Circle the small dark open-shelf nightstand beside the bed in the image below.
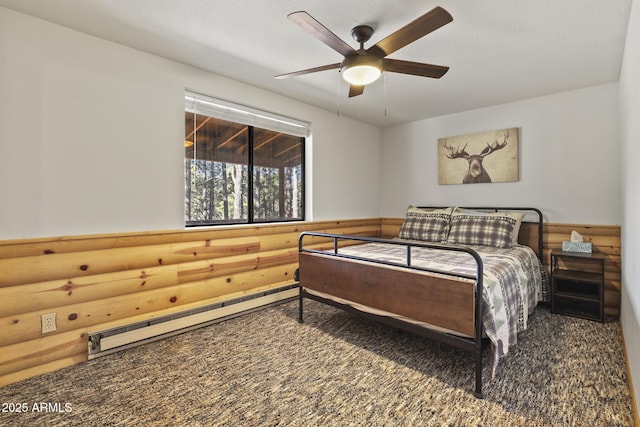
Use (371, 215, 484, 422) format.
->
(551, 251, 605, 322)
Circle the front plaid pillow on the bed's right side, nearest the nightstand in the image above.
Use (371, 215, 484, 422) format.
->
(447, 214, 517, 248)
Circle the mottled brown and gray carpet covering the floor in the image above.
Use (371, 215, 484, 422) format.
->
(0, 301, 633, 426)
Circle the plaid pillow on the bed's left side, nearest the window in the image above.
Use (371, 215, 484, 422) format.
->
(398, 206, 451, 242)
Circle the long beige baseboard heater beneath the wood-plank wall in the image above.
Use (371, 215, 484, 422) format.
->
(88, 284, 299, 359)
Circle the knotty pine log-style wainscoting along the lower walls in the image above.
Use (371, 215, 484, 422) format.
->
(0, 218, 620, 386)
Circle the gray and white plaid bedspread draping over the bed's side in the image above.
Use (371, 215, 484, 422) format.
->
(339, 243, 546, 369)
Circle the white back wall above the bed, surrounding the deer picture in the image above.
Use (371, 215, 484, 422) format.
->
(381, 83, 621, 224)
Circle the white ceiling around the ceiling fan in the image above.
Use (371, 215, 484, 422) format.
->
(0, 0, 632, 126)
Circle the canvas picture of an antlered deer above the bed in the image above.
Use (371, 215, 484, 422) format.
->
(438, 128, 518, 184)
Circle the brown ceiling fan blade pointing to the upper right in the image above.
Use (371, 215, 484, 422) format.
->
(367, 6, 453, 58)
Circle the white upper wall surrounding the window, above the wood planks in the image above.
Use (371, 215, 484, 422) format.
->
(0, 8, 381, 239)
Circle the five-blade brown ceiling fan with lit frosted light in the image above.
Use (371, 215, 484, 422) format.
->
(275, 6, 453, 97)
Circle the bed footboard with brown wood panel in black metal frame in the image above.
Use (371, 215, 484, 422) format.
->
(299, 232, 483, 398)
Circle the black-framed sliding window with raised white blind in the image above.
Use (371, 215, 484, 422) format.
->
(184, 91, 309, 226)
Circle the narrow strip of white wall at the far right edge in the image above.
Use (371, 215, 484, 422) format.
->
(620, 1, 640, 409)
